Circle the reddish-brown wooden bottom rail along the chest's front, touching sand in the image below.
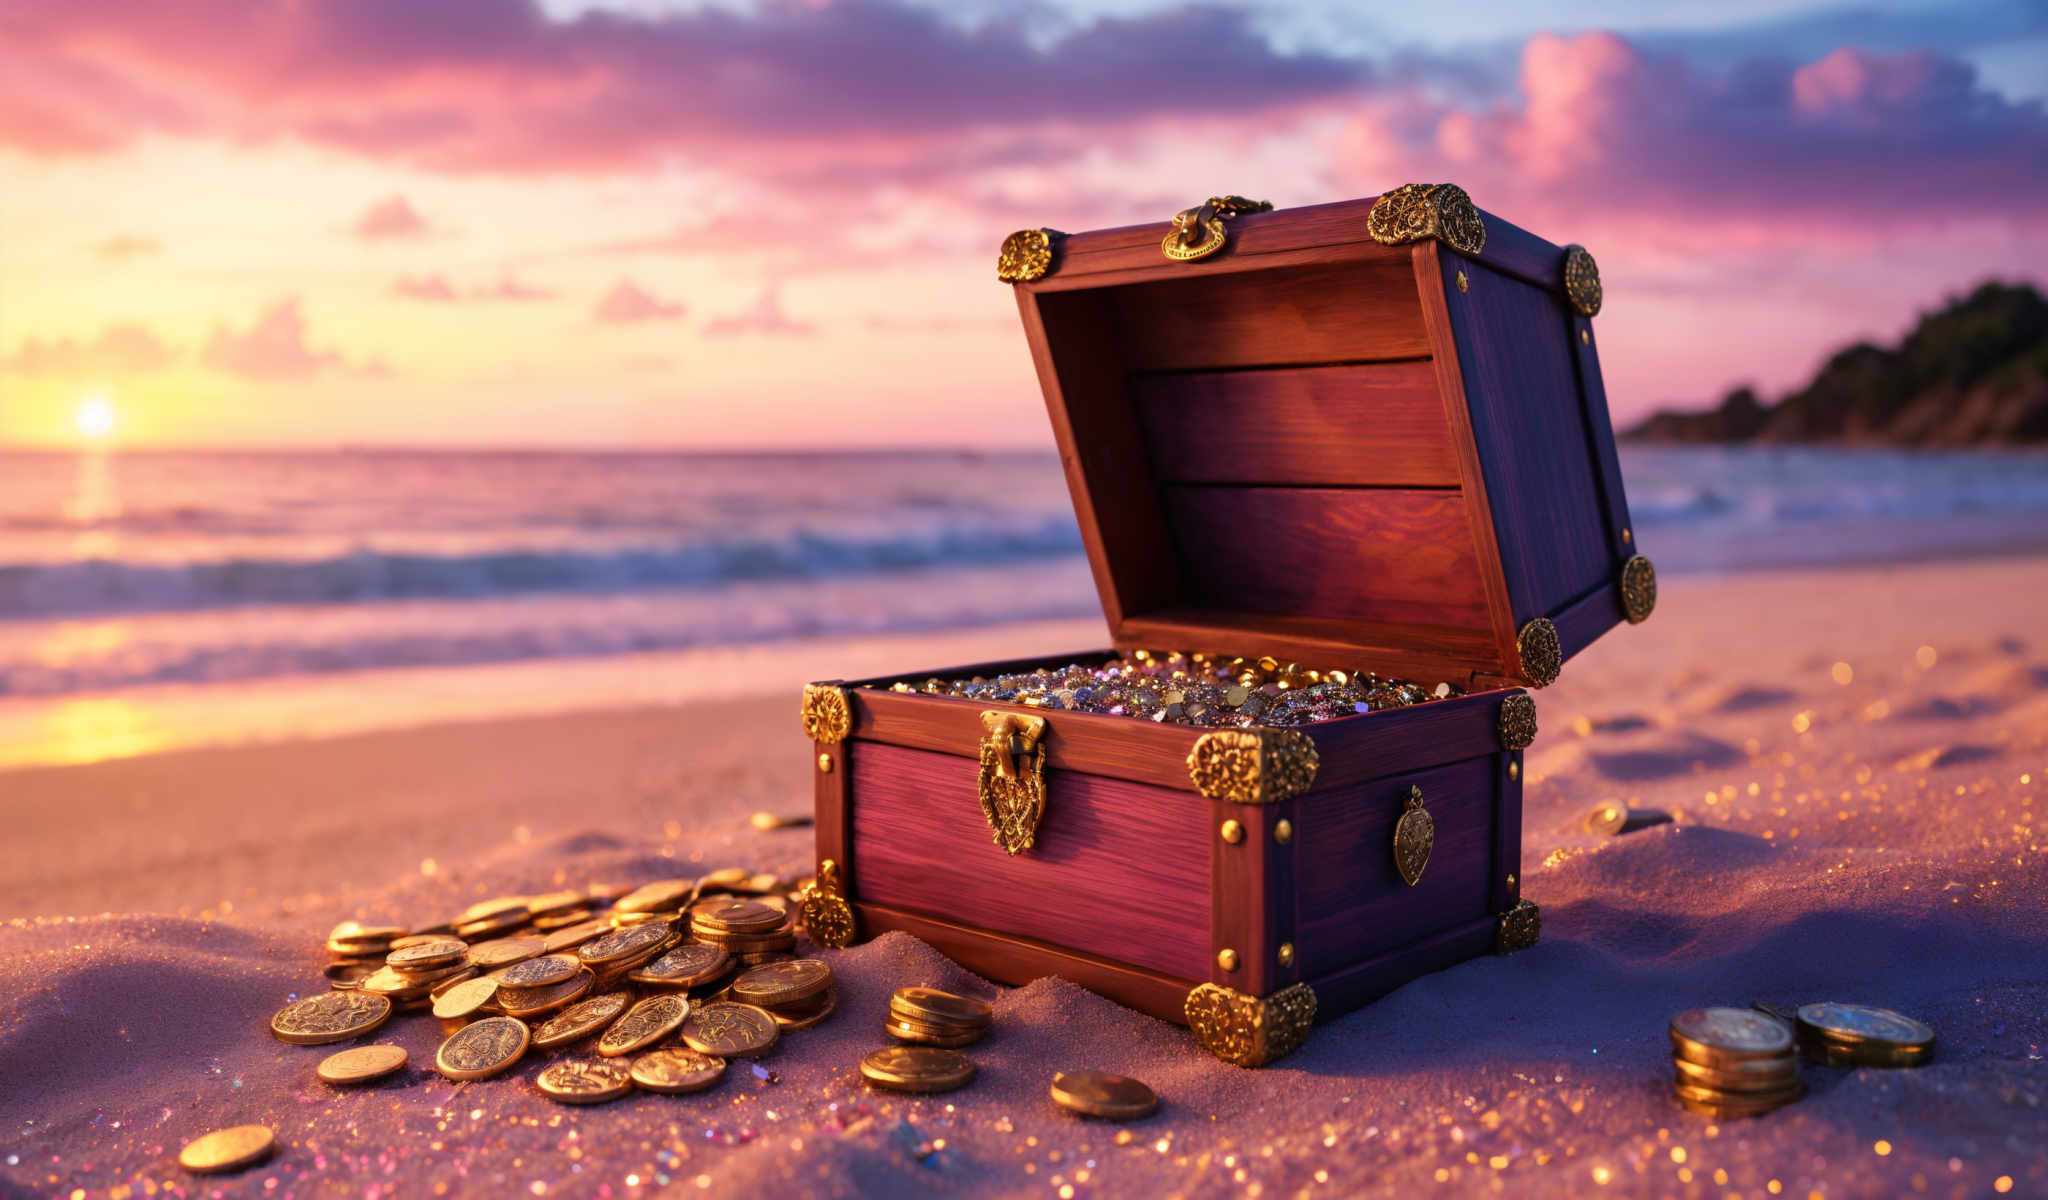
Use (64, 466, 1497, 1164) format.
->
(854, 903, 1194, 1026)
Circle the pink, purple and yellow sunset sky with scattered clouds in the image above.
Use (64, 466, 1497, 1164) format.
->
(0, 0, 2048, 446)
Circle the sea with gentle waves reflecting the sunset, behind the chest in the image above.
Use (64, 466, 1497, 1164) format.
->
(0, 448, 2048, 762)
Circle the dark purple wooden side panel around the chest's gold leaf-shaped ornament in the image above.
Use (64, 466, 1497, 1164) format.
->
(1294, 756, 1499, 979)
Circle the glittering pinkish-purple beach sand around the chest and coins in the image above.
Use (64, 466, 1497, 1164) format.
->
(0, 557, 2048, 1198)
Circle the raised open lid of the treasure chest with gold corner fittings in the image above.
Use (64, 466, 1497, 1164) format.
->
(997, 184, 1657, 688)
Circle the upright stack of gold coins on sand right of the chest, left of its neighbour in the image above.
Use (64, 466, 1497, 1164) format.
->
(1671, 1008, 1806, 1120)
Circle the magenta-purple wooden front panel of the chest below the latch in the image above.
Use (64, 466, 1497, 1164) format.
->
(850, 737, 1210, 979)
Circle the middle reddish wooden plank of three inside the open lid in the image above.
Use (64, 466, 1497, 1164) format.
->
(1130, 362, 1458, 487)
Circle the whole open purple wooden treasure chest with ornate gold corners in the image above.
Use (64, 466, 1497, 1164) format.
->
(803, 184, 1657, 1065)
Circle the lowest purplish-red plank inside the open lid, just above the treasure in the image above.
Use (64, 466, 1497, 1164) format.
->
(1163, 485, 1489, 631)
